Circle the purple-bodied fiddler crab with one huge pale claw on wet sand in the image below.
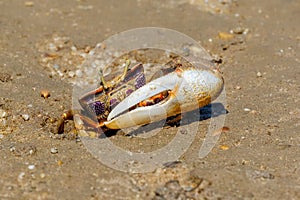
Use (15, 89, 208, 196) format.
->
(58, 57, 224, 133)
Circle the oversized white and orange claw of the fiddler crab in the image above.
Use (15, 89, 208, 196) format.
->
(105, 67, 224, 129)
